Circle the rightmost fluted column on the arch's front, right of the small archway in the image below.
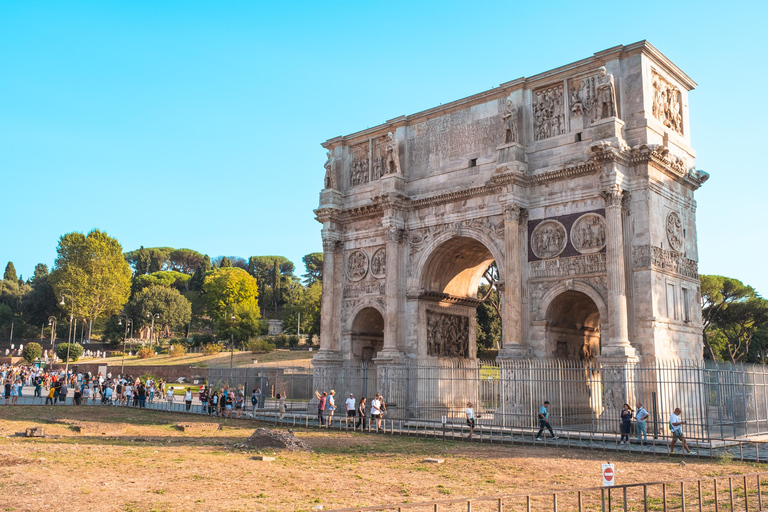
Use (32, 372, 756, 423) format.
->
(601, 185, 635, 357)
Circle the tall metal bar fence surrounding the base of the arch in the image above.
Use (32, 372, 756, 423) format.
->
(209, 359, 768, 439)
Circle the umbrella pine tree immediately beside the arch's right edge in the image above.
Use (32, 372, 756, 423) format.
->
(700, 274, 757, 361)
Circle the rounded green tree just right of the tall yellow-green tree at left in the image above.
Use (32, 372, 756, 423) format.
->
(126, 285, 192, 330)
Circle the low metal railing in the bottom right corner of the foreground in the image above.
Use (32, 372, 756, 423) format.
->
(330, 473, 768, 512)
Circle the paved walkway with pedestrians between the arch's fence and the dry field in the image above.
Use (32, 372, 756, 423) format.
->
(10, 396, 768, 462)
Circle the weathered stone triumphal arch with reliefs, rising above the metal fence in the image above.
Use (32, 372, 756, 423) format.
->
(315, 41, 708, 364)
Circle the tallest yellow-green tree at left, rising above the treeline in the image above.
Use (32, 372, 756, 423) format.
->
(51, 229, 131, 339)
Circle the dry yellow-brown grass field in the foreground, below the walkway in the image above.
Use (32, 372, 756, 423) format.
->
(0, 406, 766, 512)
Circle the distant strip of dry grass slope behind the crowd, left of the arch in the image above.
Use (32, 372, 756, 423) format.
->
(78, 350, 315, 368)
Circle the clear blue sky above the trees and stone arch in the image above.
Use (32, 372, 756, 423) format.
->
(0, 0, 768, 294)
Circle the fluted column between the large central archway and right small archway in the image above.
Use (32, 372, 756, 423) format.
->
(499, 204, 529, 358)
